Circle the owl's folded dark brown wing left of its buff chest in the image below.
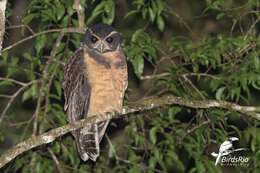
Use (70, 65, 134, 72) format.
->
(63, 48, 91, 123)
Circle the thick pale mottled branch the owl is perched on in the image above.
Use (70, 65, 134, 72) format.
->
(0, 96, 260, 168)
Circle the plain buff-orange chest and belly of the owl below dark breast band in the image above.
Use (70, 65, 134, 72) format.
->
(84, 53, 127, 115)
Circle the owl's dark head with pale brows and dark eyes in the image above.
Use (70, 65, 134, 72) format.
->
(84, 24, 122, 54)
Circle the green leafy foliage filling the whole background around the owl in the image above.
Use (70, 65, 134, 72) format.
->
(0, 0, 260, 173)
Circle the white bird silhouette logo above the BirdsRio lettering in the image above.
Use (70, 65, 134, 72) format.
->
(211, 137, 246, 166)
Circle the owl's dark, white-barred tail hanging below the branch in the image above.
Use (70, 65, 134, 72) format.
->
(74, 120, 109, 162)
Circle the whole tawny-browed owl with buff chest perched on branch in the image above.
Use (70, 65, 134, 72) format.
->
(63, 24, 127, 161)
